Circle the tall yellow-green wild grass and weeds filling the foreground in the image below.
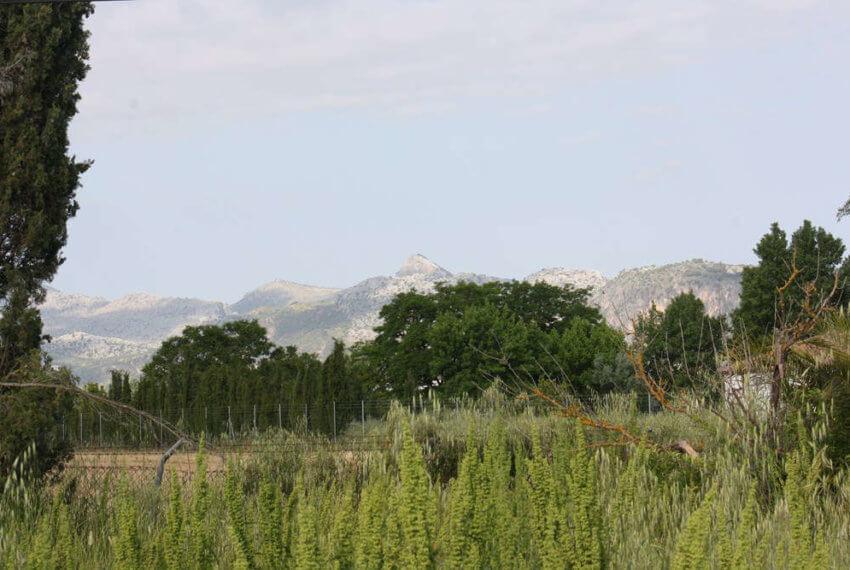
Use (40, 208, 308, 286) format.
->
(0, 393, 850, 569)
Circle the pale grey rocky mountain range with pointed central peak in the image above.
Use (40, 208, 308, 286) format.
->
(40, 254, 743, 382)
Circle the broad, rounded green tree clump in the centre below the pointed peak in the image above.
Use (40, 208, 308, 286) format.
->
(355, 282, 624, 398)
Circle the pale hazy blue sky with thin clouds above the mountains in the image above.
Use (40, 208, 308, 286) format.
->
(54, 0, 850, 301)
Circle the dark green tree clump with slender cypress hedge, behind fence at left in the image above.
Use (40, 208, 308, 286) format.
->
(130, 321, 362, 433)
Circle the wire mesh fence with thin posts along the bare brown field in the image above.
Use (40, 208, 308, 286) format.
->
(57, 390, 653, 492)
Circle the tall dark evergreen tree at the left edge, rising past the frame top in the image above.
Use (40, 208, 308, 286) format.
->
(0, 2, 92, 474)
